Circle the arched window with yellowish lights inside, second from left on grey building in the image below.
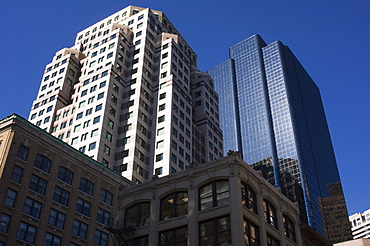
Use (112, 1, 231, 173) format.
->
(161, 192, 189, 220)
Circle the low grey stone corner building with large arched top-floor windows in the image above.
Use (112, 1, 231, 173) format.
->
(112, 152, 304, 246)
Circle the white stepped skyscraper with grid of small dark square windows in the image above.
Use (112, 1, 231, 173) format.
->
(29, 6, 222, 183)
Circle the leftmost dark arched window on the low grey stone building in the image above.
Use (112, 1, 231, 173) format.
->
(124, 202, 150, 228)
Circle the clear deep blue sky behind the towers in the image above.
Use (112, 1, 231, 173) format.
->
(0, 0, 370, 214)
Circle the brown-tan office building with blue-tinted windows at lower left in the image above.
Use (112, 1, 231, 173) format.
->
(0, 114, 133, 246)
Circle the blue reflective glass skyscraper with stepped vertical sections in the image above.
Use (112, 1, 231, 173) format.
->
(208, 35, 351, 242)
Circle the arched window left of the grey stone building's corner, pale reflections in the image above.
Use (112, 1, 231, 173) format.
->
(199, 180, 229, 210)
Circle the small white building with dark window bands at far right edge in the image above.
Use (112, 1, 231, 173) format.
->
(349, 209, 370, 239)
